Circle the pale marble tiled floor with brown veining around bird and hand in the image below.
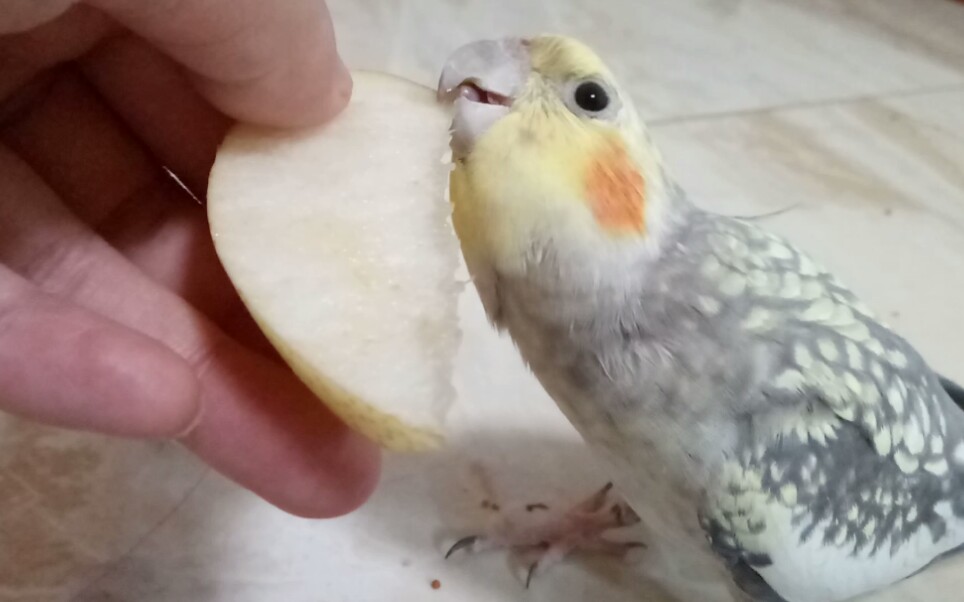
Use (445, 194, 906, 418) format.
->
(0, 0, 964, 602)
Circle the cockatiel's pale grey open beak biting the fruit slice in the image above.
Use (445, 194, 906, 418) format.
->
(438, 38, 531, 158)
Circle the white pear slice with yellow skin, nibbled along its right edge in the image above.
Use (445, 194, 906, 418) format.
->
(208, 72, 462, 451)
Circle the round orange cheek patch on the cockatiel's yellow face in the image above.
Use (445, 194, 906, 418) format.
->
(586, 144, 646, 233)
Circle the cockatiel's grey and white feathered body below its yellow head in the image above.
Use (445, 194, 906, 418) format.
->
(490, 201, 964, 602)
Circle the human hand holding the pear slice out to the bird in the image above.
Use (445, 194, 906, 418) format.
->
(0, 0, 379, 517)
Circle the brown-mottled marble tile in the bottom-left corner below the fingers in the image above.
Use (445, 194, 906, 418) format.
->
(0, 417, 206, 601)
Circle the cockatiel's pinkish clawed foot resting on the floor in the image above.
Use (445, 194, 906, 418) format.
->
(445, 483, 646, 587)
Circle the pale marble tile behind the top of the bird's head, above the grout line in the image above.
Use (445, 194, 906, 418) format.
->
(330, 0, 964, 117)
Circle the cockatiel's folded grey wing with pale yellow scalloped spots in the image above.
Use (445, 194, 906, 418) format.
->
(701, 218, 964, 602)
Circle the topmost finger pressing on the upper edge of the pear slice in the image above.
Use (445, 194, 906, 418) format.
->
(88, 0, 352, 127)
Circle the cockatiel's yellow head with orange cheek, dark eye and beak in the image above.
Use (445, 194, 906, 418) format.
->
(438, 36, 667, 286)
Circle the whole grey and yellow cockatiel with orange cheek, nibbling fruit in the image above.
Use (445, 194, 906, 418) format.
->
(439, 36, 964, 602)
